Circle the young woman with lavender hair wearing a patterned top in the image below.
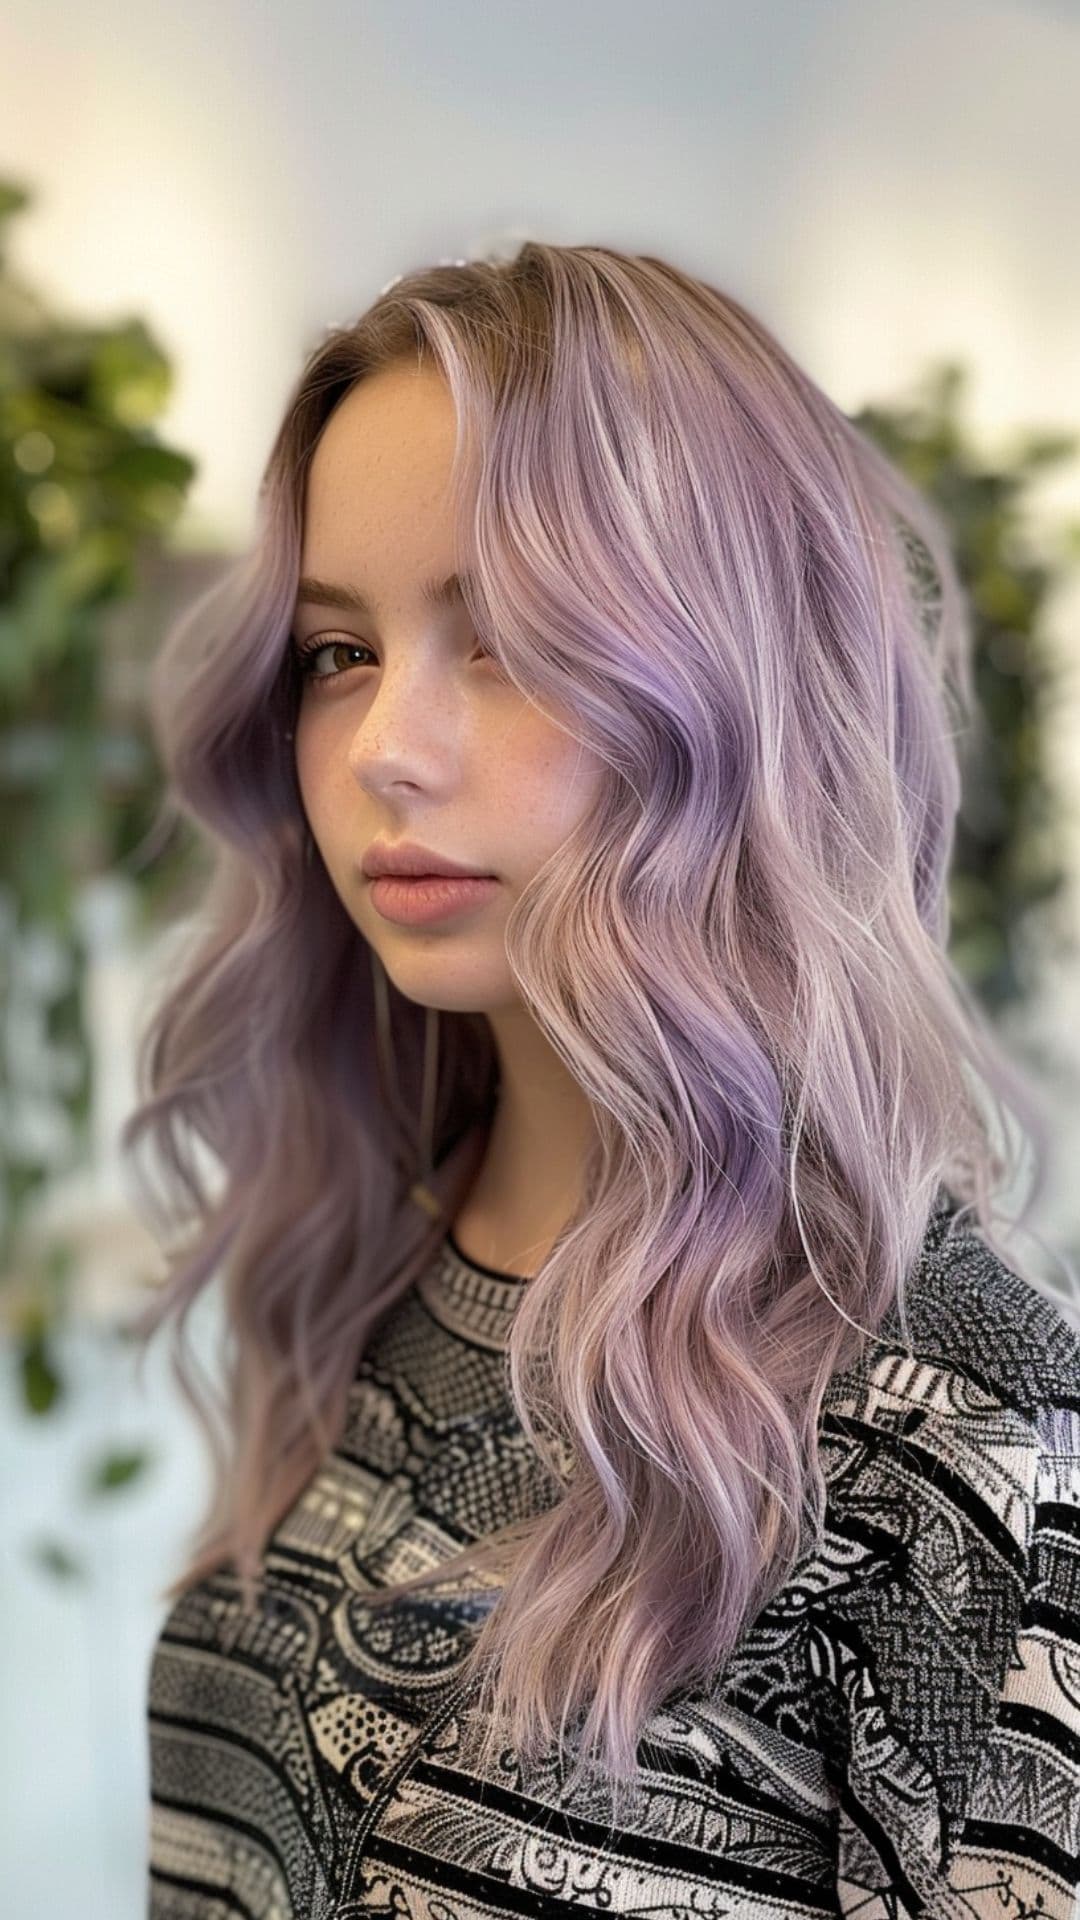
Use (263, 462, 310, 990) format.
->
(127, 242, 1080, 1920)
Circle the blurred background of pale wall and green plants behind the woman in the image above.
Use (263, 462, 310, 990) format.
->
(0, 0, 1080, 1920)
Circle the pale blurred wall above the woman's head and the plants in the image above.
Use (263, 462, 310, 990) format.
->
(0, 0, 1080, 538)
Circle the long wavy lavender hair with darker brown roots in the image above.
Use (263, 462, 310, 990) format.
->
(123, 240, 1068, 1782)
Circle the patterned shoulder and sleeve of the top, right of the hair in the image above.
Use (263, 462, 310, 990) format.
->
(805, 1210, 1080, 1914)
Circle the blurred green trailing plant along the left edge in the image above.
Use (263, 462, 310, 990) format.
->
(0, 180, 196, 1543)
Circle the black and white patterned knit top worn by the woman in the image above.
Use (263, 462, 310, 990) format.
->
(148, 1188, 1080, 1920)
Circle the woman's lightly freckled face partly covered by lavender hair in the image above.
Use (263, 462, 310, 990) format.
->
(292, 365, 603, 1012)
